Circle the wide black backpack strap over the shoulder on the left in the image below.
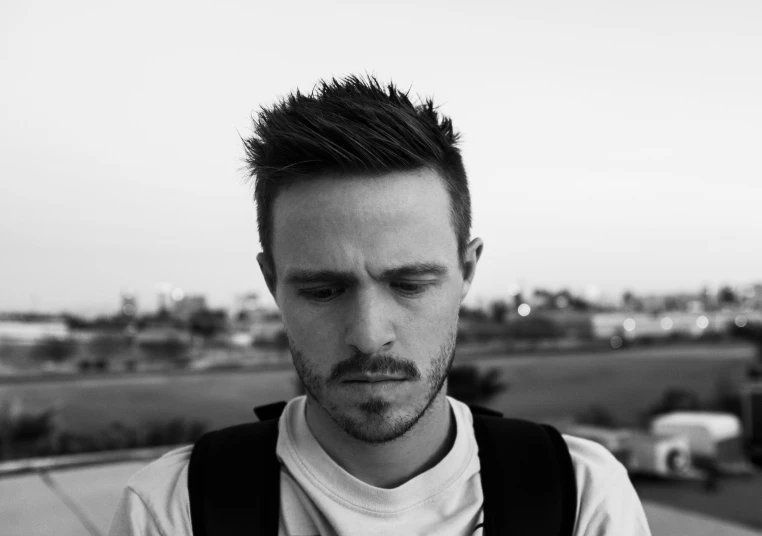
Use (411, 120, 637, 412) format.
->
(188, 403, 285, 536)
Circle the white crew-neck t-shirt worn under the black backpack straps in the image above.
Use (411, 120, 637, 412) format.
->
(109, 397, 650, 536)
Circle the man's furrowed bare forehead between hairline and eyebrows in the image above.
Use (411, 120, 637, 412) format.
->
(273, 172, 457, 271)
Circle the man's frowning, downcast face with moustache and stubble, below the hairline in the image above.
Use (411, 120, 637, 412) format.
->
(262, 170, 475, 443)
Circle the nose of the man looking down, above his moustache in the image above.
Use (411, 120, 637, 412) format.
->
(345, 290, 395, 355)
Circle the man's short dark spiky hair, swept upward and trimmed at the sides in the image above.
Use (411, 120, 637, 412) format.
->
(243, 76, 471, 268)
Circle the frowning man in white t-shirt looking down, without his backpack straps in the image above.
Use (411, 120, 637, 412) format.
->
(111, 77, 649, 536)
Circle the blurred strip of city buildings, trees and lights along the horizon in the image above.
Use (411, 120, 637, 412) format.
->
(0, 283, 762, 375)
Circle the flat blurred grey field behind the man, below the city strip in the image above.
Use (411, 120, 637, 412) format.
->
(0, 344, 754, 432)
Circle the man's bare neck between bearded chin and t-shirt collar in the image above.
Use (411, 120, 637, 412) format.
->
(306, 390, 456, 489)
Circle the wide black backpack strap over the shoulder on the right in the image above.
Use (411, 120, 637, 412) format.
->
(473, 412, 577, 536)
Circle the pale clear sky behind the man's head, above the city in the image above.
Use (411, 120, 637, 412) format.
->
(0, 0, 762, 314)
